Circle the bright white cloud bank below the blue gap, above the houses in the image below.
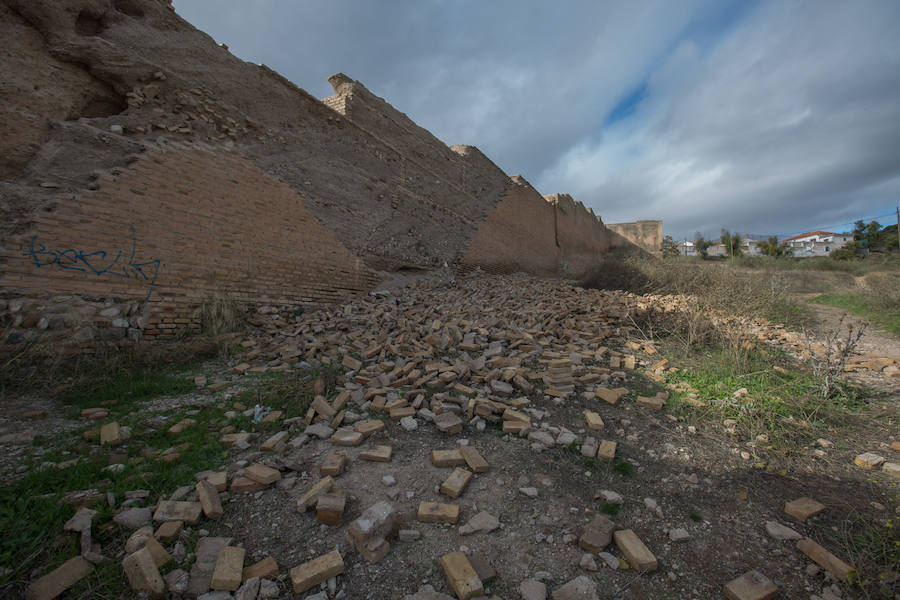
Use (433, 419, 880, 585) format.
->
(540, 2, 900, 237)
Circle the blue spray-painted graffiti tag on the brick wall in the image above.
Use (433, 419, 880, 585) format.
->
(23, 227, 162, 300)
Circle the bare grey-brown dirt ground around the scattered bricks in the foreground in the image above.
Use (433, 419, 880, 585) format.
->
(0, 274, 900, 600)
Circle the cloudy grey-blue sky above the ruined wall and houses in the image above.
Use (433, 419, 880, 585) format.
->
(175, 0, 900, 239)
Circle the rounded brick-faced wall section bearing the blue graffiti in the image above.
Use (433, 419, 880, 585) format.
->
(0, 142, 378, 341)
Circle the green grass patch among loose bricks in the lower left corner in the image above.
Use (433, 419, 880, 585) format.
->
(0, 378, 243, 599)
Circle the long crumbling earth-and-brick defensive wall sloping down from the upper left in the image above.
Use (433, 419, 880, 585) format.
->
(0, 0, 648, 349)
